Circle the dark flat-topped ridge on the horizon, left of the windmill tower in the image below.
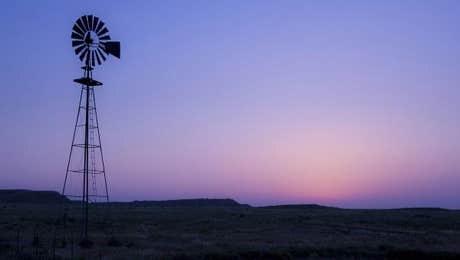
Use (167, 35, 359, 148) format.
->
(0, 190, 69, 204)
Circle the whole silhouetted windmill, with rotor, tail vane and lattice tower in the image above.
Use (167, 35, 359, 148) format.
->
(62, 15, 120, 245)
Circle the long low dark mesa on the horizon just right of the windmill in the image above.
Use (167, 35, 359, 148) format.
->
(111, 199, 249, 207)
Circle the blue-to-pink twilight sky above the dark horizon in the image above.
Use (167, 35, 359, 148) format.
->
(0, 0, 460, 208)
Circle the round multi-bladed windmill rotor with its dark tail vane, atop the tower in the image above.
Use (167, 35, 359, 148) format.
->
(70, 15, 120, 67)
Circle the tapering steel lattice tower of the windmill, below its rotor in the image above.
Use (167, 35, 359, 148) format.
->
(62, 67, 109, 242)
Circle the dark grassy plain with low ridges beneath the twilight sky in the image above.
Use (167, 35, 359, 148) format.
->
(0, 190, 460, 259)
